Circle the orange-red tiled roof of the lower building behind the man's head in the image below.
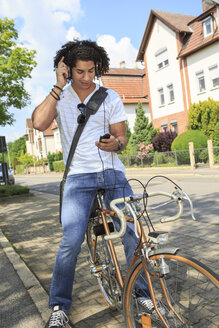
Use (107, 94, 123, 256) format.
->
(101, 68, 148, 103)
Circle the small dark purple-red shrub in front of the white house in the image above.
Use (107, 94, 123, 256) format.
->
(152, 131, 177, 152)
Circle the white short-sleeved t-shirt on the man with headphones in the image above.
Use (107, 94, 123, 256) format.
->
(56, 85, 127, 174)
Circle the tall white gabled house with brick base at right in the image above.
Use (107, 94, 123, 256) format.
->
(137, 0, 219, 133)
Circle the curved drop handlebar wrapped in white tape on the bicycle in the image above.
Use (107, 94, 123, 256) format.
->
(104, 191, 183, 240)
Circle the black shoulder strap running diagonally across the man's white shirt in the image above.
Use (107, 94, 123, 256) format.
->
(59, 87, 108, 222)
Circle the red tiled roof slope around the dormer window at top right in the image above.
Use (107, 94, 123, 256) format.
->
(179, 7, 219, 57)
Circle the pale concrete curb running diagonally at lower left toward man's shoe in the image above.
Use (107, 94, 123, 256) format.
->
(0, 230, 51, 323)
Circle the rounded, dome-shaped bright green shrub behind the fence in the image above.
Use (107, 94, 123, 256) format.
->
(171, 130, 208, 150)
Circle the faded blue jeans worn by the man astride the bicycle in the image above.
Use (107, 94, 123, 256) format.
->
(49, 169, 148, 312)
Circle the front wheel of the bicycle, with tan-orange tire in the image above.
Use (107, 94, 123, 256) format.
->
(124, 253, 219, 328)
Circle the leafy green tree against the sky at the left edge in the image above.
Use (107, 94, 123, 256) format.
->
(0, 18, 36, 126)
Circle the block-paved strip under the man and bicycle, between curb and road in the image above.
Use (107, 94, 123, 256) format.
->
(0, 194, 219, 328)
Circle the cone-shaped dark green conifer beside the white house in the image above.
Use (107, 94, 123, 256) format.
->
(130, 102, 157, 150)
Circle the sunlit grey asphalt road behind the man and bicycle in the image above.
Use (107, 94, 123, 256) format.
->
(16, 169, 219, 226)
